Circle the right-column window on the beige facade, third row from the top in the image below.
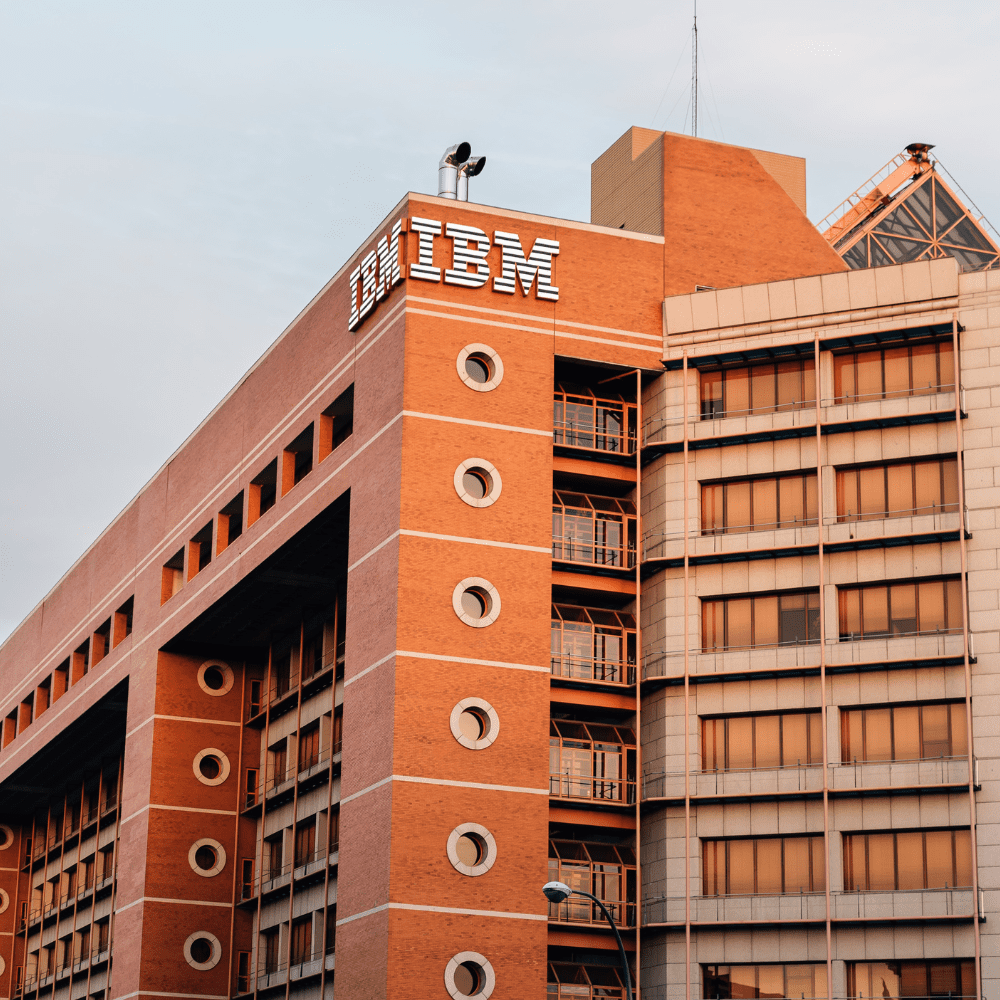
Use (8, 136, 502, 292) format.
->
(837, 579, 962, 642)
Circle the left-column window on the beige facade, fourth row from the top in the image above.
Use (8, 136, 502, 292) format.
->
(701, 712, 823, 771)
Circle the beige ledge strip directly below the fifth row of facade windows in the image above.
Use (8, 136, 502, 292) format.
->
(642, 888, 983, 925)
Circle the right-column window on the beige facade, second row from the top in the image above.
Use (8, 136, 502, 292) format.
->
(837, 458, 958, 522)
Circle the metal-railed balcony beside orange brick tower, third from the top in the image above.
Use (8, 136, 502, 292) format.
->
(551, 604, 636, 685)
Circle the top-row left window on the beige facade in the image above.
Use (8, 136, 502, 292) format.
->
(701, 358, 816, 420)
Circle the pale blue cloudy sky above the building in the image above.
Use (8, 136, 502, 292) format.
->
(0, 0, 1000, 640)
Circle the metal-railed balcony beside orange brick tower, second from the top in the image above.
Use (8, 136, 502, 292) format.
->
(552, 490, 636, 571)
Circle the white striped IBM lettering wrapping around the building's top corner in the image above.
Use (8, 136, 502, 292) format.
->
(347, 216, 559, 330)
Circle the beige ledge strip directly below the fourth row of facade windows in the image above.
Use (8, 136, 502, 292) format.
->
(642, 756, 979, 801)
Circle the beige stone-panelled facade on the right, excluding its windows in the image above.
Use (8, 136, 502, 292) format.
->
(641, 259, 1000, 997)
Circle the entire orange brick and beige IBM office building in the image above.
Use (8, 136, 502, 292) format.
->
(0, 128, 1000, 1000)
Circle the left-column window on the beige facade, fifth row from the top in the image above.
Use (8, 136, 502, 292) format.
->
(701, 837, 826, 896)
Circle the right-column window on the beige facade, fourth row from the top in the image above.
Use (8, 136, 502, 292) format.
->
(840, 702, 969, 764)
